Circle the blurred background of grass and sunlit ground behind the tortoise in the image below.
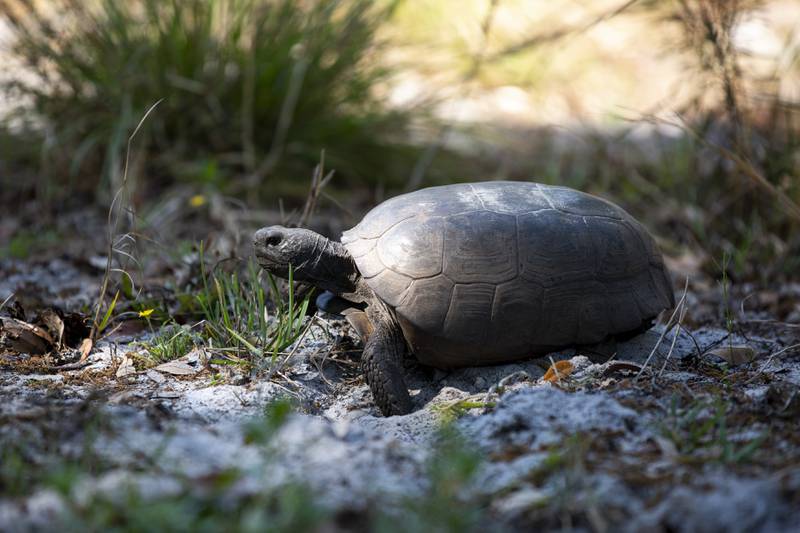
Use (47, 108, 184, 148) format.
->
(0, 0, 800, 281)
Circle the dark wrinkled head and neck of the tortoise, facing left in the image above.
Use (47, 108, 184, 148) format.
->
(253, 226, 360, 294)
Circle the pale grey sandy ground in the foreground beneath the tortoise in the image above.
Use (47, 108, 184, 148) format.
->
(0, 256, 800, 531)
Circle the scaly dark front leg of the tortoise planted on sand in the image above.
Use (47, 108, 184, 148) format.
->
(361, 323, 411, 416)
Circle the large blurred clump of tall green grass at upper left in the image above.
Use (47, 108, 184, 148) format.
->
(0, 0, 422, 202)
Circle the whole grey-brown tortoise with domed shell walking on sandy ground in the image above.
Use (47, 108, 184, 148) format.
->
(253, 181, 675, 416)
